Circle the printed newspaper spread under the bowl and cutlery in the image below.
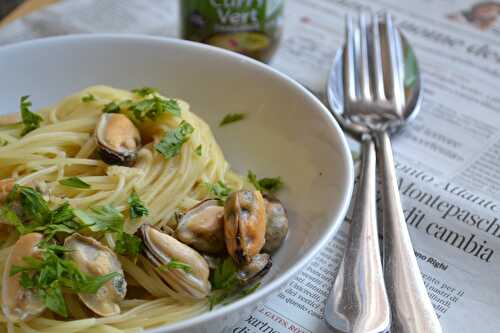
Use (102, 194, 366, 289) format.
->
(0, 0, 500, 333)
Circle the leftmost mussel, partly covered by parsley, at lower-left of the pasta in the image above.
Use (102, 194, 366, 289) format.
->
(2, 233, 45, 322)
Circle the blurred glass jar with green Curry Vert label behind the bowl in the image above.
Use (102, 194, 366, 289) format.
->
(179, 0, 285, 62)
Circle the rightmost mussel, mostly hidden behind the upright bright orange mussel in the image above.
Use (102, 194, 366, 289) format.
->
(262, 196, 288, 253)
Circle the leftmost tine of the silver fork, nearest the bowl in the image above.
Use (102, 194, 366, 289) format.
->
(343, 14, 356, 102)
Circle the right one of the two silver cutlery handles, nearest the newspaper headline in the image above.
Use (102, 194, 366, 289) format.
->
(374, 131, 442, 333)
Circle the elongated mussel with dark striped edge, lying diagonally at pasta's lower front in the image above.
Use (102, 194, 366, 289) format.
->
(140, 224, 211, 299)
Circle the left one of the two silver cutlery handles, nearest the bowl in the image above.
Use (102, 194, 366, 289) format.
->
(325, 136, 390, 333)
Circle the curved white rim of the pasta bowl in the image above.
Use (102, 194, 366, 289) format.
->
(0, 33, 354, 333)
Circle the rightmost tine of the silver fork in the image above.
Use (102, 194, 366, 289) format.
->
(385, 13, 405, 114)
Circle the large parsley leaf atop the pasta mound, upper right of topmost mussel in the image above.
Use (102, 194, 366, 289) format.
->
(129, 96, 181, 121)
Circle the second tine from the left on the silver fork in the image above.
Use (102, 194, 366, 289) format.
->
(356, 12, 372, 102)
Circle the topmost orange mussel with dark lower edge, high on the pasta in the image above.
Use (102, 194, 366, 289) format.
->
(95, 113, 141, 166)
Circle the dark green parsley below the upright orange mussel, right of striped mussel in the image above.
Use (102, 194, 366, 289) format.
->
(208, 257, 260, 310)
